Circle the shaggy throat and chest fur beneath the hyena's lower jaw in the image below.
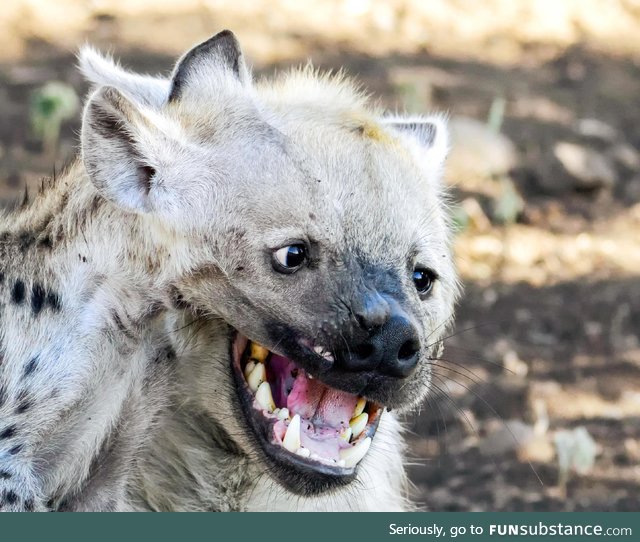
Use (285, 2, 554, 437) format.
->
(129, 405, 412, 512)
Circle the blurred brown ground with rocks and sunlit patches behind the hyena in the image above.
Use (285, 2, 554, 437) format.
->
(0, 0, 640, 511)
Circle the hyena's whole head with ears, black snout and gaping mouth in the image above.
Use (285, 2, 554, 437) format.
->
(82, 32, 457, 494)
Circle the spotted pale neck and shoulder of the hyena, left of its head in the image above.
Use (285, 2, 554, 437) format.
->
(0, 159, 175, 510)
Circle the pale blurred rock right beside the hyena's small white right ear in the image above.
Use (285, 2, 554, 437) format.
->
(447, 117, 518, 181)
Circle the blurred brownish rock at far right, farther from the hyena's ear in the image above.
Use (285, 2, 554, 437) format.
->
(553, 141, 617, 190)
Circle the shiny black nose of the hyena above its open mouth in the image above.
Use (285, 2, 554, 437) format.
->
(338, 298, 420, 377)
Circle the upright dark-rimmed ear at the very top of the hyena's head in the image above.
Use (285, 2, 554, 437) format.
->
(169, 30, 251, 102)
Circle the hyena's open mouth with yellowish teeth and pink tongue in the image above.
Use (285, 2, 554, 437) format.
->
(232, 333, 382, 486)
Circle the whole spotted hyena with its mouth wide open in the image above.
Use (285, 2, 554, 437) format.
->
(0, 31, 457, 510)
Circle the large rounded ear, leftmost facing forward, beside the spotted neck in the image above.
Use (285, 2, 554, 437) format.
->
(81, 87, 179, 212)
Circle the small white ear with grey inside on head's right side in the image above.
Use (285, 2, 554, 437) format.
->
(384, 116, 449, 172)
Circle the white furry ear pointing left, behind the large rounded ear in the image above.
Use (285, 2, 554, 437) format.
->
(78, 45, 170, 108)
